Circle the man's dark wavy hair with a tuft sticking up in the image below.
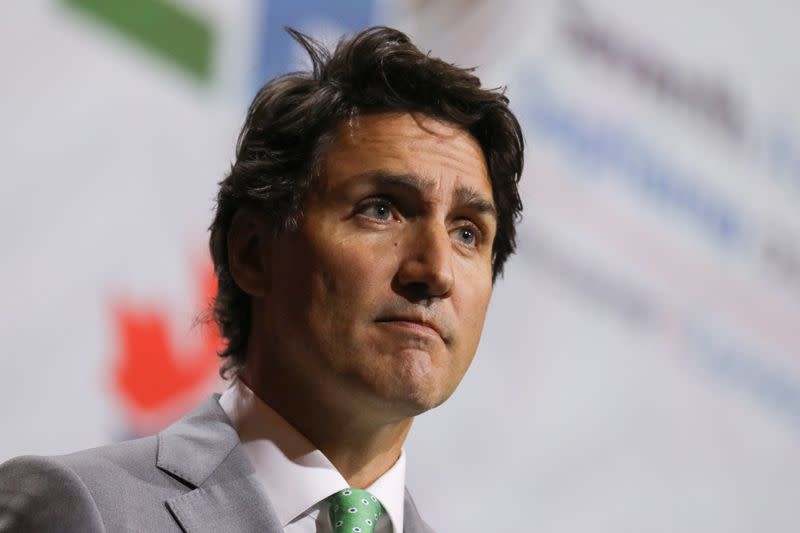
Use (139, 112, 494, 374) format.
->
(210, 23, 523, 377)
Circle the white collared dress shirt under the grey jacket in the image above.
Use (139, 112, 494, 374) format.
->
(219, 379, 406, 533)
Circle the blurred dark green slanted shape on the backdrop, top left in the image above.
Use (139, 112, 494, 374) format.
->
(64, 0, 214, 81)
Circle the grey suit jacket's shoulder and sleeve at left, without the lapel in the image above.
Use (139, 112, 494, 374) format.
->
(0, 436, 187, 532)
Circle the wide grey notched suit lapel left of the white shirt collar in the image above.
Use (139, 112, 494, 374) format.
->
(156, 395, 283, 533)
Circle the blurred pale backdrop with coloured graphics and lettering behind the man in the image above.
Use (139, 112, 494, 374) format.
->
(0, 0, 800, 533)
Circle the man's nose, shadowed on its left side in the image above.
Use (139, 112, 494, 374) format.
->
(397, 223, 454, 300)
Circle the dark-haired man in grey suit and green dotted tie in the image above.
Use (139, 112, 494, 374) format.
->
(0, 27, 522, 533)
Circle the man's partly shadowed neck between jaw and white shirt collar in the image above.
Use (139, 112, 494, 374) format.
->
(240, 368, 413, 489)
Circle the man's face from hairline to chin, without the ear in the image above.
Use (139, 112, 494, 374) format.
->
(256, 113, 496, 417)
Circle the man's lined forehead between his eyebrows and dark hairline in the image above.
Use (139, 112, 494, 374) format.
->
(322, 113, 492, 199)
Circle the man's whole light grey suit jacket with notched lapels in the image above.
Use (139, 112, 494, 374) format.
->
(0, 395, 432, 533)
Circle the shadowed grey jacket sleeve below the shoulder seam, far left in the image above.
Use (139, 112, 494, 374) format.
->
(0, 456, 103, 532)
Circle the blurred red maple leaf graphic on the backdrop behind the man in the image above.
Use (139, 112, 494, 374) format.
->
(113, 262, 222, 431)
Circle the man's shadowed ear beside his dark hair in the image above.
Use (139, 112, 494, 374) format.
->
(228, 208, 272, 297)
